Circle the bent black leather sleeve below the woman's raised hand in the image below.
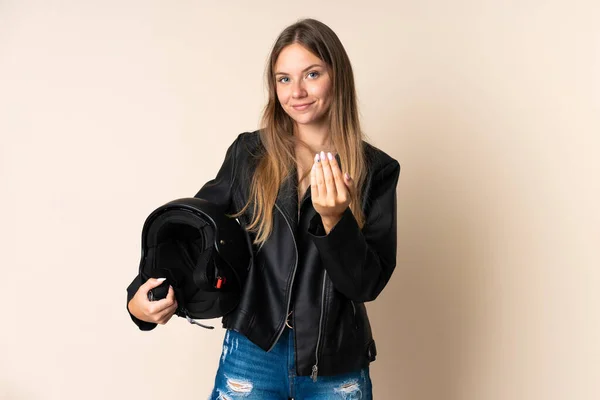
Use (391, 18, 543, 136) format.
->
(309, 160, 400, 302)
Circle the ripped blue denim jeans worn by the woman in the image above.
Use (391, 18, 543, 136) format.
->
(210, 328, 373, 400)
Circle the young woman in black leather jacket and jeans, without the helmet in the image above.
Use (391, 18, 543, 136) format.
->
(128, 19, 400, 400)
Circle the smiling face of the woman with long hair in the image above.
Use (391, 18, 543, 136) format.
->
(275, 43, 332, 125)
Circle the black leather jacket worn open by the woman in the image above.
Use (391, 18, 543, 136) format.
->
(128, 132, 400, 376)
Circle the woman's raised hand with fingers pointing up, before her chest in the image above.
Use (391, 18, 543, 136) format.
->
(310, 152, 356, 233)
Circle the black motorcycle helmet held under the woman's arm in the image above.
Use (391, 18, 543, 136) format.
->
(139, 198, 252, 328)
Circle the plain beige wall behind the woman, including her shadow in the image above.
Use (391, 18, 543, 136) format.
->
(0, 0, 600, 400)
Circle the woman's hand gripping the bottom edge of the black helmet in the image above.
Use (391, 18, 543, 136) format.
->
(127, 278, 177, 325)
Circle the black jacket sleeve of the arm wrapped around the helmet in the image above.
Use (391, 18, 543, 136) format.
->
(127, 134, 243, 331)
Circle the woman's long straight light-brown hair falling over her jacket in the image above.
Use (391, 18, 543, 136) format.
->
(238, 19, 366, 244)
